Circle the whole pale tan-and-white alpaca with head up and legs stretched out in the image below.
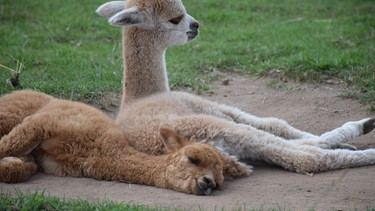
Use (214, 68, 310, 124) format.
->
(97, 0, 375, 177)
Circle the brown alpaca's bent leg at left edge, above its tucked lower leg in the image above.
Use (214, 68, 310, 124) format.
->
(0, 116, 48, 158)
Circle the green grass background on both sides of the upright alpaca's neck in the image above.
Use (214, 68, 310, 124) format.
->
(0, 0, 375, 110)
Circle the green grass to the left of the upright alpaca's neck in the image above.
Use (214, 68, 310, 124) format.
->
(0, 0, 122, 100)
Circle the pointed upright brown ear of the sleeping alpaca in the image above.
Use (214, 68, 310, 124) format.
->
(160, 128, 187, 153)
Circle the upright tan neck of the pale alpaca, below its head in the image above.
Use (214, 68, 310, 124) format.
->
(122, 28, 169, 104)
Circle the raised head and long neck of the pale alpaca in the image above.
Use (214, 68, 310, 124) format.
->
(97, 1, 199, 105)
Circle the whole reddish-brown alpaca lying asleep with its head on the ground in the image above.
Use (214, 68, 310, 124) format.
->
(0, 91, 228, 195)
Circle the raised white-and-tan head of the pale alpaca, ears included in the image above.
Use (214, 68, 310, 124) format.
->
(96, 0, 199, 47)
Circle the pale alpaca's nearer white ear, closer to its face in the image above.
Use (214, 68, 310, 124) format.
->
(108, 7, 144, 26)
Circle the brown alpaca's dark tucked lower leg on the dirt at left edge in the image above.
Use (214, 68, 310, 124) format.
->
(0, 157, 37, 183)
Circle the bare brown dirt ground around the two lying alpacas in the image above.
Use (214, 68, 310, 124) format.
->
(0, 76, 375, 210)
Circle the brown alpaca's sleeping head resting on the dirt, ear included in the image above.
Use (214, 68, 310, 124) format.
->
(160, 128, 224, 195)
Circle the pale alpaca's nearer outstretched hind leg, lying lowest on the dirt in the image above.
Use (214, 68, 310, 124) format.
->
(168, 115, 375, 173)
